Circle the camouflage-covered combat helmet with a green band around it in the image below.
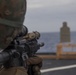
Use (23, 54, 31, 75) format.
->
(0, 0, 26, 49)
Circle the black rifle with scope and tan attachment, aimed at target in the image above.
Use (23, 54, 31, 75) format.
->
(0, 27, 44, 75)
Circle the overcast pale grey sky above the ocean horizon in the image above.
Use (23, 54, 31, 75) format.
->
(24, 0, 76, 32)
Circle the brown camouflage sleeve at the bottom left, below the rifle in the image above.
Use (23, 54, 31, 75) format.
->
(0, 67, 28, 75)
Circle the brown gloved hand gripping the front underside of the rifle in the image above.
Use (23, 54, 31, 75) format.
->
(27, 56, 42, 75)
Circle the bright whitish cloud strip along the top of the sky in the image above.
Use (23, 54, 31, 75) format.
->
(27, 0, 73, 9)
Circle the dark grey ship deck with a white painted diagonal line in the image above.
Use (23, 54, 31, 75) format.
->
(41, 59, 76, 75)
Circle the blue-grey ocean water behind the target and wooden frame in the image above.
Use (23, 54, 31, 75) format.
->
(38, 32, 76, 53)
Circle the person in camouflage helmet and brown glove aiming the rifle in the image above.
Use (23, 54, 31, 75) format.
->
(0, 0, 42, 75)
